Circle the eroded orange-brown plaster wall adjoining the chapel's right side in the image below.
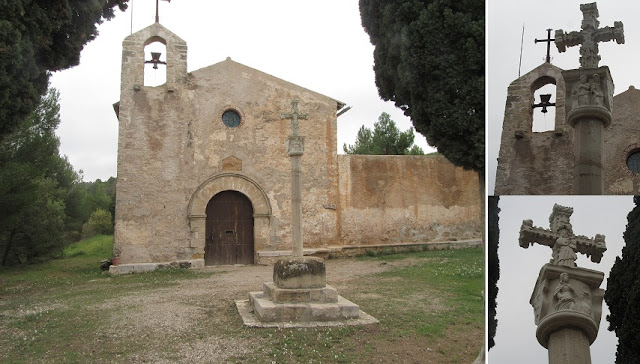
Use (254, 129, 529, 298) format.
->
(338, 155, 483, 246)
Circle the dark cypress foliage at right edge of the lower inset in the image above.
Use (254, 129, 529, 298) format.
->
(604, 196, 640, 364)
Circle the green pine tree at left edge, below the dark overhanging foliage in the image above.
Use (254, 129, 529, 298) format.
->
(0, 89, 78, 265)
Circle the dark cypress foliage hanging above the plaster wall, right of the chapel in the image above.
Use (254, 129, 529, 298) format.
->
(359, 0, 485, 172)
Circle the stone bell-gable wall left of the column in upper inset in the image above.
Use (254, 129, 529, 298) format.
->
(495, 63, 574, 195)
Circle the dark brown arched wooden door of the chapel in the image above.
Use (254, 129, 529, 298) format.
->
(204, 191, 253, 265)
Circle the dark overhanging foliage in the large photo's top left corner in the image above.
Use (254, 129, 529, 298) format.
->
(0, 0, 128, 140)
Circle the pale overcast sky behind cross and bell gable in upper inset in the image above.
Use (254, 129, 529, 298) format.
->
(486, 0, 640, 195)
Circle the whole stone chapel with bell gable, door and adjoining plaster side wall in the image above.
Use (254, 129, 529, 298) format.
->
(111, 23, 483, 273)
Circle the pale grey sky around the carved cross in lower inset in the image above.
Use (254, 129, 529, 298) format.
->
(489, 196, 634, 364)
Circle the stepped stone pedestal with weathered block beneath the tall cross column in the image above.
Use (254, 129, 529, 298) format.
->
(236, 257, 378, 327)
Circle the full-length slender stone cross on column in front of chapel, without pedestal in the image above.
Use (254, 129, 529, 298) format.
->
(280, 100, 309, 257)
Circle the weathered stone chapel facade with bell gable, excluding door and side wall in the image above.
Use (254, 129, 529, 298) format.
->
(115, 24, 338, 264)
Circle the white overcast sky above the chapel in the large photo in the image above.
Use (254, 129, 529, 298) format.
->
(47, 0, 434, 181)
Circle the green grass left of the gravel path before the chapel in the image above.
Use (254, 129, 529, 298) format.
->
(0, 236, 219, 362)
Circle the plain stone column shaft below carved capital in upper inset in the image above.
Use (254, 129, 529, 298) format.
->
(573, 117, 604, 195)
